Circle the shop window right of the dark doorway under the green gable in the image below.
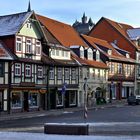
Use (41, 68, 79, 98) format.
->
(29, 93, 38, 107)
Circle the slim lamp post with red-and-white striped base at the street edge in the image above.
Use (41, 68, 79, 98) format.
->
(84, 77, 87, 120)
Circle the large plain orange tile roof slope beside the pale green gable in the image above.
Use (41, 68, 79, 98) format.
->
(37, 15, 87, 47)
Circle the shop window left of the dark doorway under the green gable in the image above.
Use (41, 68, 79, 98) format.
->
(12, 92, 22, 108)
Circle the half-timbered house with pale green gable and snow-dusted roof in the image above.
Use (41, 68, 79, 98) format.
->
(0, 11, 47, 111)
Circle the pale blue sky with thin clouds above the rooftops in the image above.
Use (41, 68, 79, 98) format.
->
(0, 0, 140, 27)
